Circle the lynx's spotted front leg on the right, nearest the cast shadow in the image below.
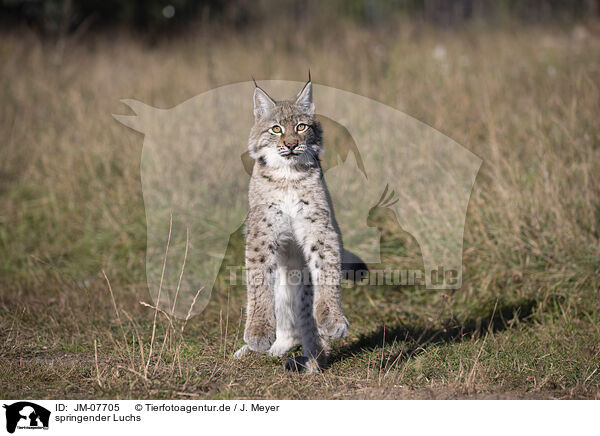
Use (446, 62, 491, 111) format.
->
(299, 218, 348, 338)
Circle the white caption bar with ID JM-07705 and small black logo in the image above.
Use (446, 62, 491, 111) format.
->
(0, 400, 600, 436)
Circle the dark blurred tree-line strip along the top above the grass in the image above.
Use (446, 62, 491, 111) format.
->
(1, 0, 600, 37)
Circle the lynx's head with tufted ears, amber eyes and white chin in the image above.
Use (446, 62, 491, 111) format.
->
(248, 75, 323, 168)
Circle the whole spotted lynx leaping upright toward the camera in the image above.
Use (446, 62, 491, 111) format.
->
(235, 75, 348, 373)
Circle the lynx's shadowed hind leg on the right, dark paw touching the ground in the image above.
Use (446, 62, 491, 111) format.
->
(284, 285, 329, 374)
